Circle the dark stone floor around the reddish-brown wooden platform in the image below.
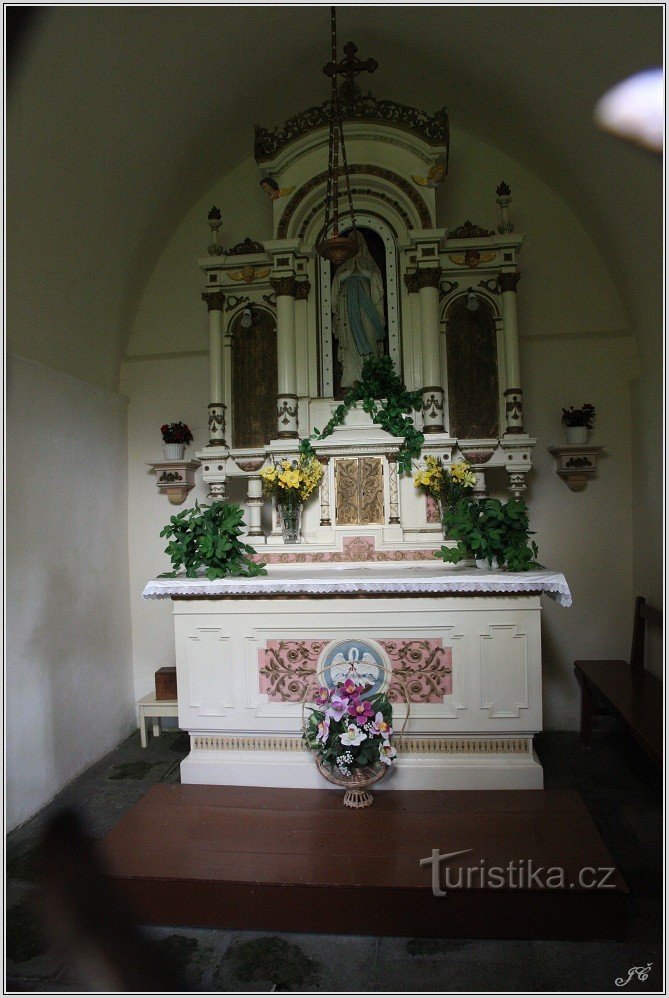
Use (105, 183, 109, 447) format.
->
(6, 731, 663, 993)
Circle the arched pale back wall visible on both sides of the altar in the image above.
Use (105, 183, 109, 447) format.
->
(122, 129, 637, 728)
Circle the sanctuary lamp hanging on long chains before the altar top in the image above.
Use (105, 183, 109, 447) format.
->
(316, 7, 378, 267)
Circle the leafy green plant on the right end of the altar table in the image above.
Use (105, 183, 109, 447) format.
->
(435, 497, 541, 572)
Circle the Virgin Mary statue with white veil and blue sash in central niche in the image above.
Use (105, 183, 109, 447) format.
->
(332, 230, 386, 388)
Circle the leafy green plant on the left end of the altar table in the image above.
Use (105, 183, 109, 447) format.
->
(160, 501, 266, 579)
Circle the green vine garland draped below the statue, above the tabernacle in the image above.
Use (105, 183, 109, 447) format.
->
(300, 354, 425, 475)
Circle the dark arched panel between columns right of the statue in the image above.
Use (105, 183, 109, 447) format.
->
(446, 298, 499, 440)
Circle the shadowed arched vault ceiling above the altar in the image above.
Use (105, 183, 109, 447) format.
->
(7, 5, 663, 388)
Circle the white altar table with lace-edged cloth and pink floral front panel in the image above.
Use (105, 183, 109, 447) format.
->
(143, 561, 571, 789)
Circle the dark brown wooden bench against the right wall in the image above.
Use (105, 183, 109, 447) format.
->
(574, 596, 664, 767)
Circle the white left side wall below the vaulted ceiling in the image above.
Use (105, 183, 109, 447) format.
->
(6, 355, 134, 828)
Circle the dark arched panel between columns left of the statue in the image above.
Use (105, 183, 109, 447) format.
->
(228, 304, 277, 447)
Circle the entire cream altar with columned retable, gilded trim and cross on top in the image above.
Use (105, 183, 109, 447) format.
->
(144, 27, 570, 790)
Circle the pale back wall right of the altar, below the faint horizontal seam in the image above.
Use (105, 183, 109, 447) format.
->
(521, 336, 637, 729)
